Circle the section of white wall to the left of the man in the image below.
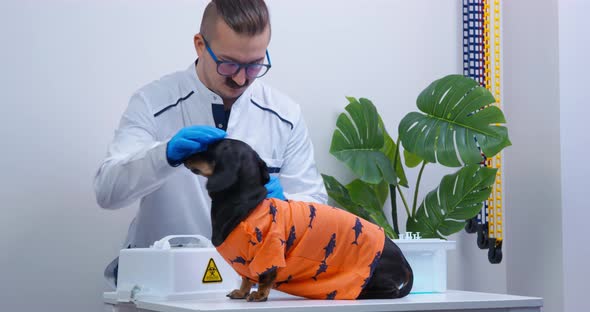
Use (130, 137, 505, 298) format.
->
(0, 0, 204, 311)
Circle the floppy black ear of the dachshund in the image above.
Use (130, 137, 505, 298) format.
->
(207, 152, 240, 193)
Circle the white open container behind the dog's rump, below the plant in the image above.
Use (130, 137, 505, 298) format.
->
(393, 238, 455, 294)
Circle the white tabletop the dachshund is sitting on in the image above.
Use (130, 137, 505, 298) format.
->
(104, 290, 543, 312)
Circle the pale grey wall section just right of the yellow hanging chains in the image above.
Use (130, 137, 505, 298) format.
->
(503, 0, 568, 311)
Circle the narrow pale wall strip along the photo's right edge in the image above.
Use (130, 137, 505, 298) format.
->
(559, 0, 590, 312)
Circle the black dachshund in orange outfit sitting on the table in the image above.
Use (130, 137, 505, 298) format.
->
(184, 139, 413, 301)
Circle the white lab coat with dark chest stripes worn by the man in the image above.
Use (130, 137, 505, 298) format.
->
(94, 64, 327, 281)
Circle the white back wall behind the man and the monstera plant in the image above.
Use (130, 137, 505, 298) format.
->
(0, 0, 508, 311)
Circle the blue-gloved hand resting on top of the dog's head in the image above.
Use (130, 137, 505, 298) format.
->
(166, 126, 226, 167)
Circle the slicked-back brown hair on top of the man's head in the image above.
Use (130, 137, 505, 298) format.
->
(200, 0, 270, 39)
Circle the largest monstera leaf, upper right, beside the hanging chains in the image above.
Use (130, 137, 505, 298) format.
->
(398, 75, 511, 167)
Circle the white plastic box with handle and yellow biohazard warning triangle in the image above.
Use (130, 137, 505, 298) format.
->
(117, 235, 241, 301)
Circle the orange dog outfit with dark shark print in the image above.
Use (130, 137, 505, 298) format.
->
(217, 198, 385, 299)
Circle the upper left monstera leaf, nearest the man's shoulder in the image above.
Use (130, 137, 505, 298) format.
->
(330, 97, 397, 184)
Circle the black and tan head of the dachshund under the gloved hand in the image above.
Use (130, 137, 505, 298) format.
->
(184, 139, 270, 198)
